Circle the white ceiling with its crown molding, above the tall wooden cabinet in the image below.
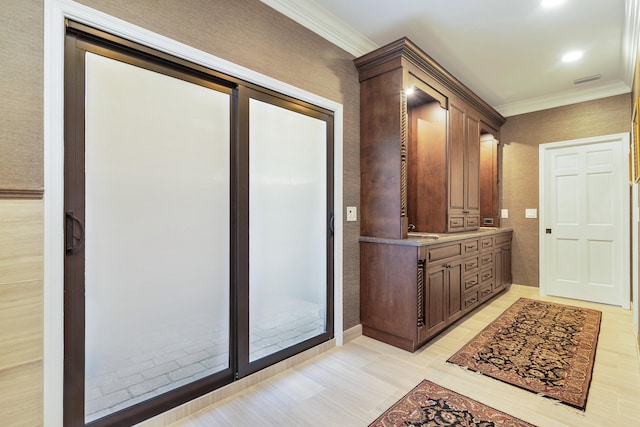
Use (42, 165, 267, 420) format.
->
(262, 0, 640, 116)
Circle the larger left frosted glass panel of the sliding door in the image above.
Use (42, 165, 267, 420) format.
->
(85, 53, 230, 421)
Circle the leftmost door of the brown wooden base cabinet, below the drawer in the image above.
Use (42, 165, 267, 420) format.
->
(424, 264, 449, 337)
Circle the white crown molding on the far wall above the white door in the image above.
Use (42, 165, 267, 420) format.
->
(494, 81, 631, 117)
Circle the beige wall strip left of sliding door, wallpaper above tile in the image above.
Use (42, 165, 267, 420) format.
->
(0, 0, 44, 427)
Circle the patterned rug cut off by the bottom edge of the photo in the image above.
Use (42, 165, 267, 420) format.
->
(369, 380, 535, 427)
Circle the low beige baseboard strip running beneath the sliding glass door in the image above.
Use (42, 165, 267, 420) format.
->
(137, 340, 338, 427)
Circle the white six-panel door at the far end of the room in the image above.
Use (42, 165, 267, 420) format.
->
(541, 135, 628, 305)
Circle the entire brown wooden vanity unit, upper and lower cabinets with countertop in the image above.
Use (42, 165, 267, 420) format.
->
(354, 38, 513, 351)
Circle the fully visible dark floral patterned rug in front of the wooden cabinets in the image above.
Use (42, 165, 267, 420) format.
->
(447, 298, 602, 410)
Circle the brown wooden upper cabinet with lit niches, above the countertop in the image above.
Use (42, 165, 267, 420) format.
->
(355, 38, 505, 239)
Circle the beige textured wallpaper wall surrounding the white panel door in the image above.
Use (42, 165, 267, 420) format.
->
(500, 94, 631, 286)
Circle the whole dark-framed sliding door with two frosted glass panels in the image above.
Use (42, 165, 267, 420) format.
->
(64, 23, 333, 427)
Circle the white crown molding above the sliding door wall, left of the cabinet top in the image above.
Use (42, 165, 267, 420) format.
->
(260, 0, 380, 58)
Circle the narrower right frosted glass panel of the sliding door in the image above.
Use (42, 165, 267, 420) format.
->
(249, 99, 327, 362)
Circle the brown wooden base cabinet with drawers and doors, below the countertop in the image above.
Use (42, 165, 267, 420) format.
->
(360, 230, 512, 351)
